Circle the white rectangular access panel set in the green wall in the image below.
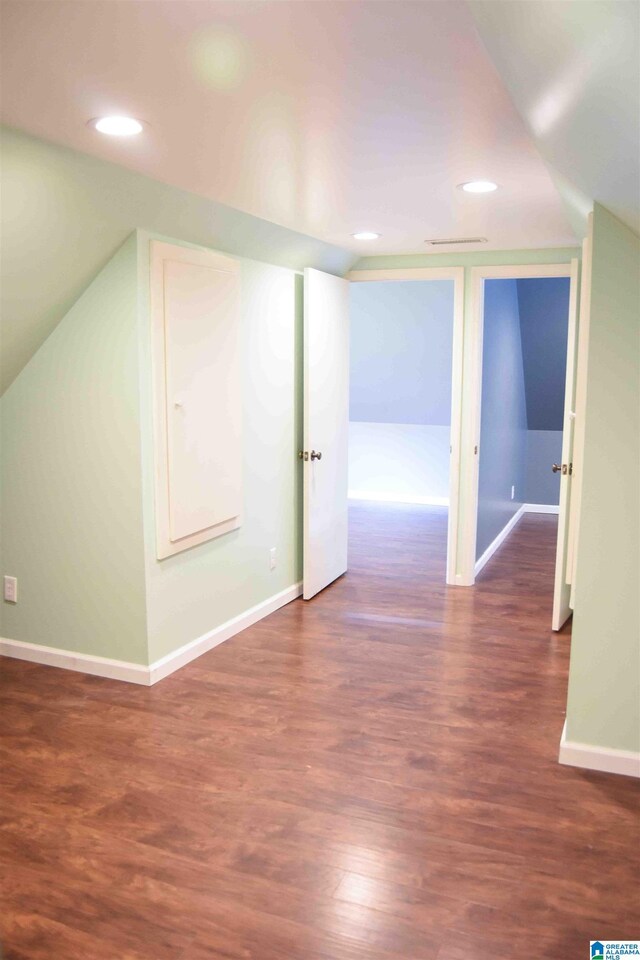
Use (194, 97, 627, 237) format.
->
(151, 241, 242, 558)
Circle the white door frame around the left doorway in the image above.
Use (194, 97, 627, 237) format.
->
(347, 267, 462, 584)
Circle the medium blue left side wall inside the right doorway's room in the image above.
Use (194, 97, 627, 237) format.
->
(476, 280, 527, 559)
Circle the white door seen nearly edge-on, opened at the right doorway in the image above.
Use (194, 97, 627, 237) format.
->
(550, 260, 578, 630)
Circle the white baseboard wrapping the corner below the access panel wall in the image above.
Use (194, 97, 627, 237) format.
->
(0, 583, 302, 687)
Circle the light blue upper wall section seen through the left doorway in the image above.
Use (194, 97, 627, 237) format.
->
(350, 280, 453, 426)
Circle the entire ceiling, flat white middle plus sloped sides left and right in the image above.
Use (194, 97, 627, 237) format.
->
(0, 0, 639, 389)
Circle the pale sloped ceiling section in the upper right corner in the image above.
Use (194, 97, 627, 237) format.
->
(468, 0, 640, 237)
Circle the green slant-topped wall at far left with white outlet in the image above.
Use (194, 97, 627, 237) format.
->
(0, 237, 147, 663)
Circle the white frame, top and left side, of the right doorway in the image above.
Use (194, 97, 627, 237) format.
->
(460, 262, 577, 585)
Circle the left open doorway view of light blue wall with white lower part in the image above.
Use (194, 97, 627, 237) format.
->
(349, 271, 461, 582)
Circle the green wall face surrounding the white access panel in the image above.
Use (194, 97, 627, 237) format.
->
(134, 233, 302, 662)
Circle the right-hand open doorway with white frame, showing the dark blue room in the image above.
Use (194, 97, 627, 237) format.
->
(472, 262, 577, 629)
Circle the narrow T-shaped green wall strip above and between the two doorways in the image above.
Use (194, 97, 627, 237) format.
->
(353, 247, 581, 574)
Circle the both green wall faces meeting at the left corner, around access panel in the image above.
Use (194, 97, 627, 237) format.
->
(0, 231, 302, 664)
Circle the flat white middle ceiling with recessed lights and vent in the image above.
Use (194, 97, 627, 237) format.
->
(1, 0, 584, 254)
